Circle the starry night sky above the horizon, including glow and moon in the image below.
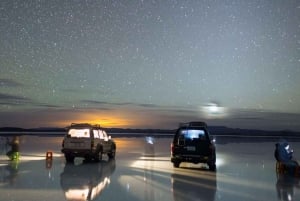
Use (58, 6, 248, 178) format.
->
(0, 0, 300, 131)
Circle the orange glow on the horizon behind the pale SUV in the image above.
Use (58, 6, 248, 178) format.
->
(35, 107, 170, 128)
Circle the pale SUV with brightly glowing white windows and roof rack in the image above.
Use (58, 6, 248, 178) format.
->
(61, 123, 116, 163)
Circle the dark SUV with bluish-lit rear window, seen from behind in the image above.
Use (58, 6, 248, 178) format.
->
(171, 122, 216, 170)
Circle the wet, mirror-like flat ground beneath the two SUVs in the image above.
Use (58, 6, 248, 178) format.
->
(0, 136, 300, 201)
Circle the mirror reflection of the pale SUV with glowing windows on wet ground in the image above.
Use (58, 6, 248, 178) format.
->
(60, 160, 116, 200)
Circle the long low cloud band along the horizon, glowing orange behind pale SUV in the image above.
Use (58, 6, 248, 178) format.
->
(0, 101, 300, 131)
